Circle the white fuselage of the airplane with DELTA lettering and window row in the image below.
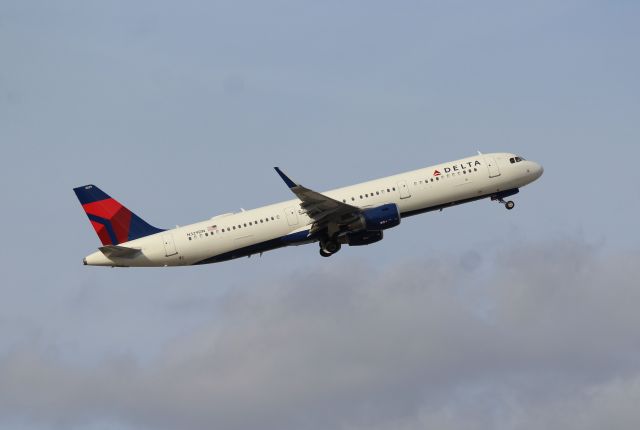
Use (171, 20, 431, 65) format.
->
(84, 153, 542, 267)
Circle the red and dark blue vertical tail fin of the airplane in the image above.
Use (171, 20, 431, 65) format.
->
(73, 185, 164, 245)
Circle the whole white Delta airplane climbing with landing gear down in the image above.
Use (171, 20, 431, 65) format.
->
(74, 152, 543, 267)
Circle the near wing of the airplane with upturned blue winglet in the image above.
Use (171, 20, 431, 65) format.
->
(275, 167, 360, 235)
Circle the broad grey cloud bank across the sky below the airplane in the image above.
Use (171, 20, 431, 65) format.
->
(0, 240, 640, 430)
